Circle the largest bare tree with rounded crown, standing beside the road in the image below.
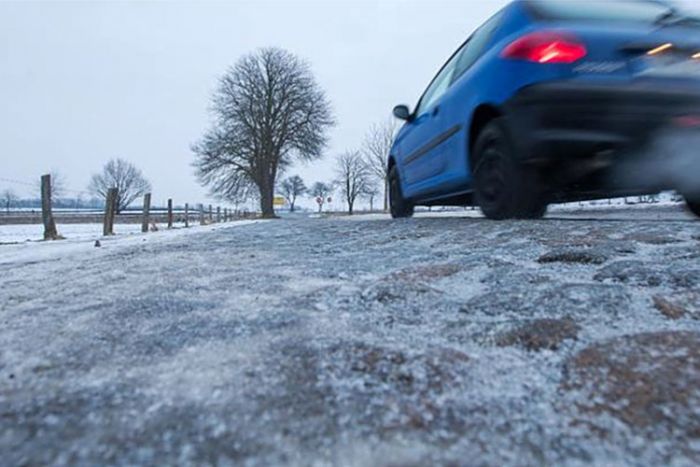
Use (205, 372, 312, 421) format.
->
(192, 48, 334, 217)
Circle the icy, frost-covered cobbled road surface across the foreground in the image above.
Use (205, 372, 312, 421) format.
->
(0, 208, 700, 466)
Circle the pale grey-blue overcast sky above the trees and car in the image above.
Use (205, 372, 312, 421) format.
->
(0, 0, 506, 203)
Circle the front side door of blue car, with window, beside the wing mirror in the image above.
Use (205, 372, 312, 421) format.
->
(399, 41, 463, 192)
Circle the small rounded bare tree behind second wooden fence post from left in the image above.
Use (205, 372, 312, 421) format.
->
(88, 159, 151, 213)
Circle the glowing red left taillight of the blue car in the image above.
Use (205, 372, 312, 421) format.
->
(501, 32, 588, 63)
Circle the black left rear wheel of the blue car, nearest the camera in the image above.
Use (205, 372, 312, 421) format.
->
(474, 119, 547, 220)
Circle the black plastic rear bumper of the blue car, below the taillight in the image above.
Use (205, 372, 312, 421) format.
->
(507, 81, 700, 161)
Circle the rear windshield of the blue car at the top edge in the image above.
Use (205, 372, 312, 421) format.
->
(529, 0, 687, 23)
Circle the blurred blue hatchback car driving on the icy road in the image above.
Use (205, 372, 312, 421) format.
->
(387, 0, 700, 219)
